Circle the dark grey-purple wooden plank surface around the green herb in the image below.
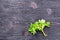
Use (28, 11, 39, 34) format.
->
(0, 0, 60, 40)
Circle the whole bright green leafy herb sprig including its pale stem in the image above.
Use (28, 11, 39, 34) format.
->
(29, 19, 50, 36)
